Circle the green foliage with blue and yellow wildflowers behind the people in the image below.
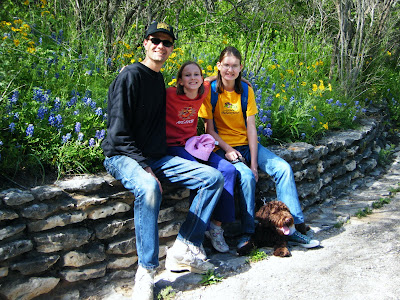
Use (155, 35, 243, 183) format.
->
(0, 0, 400, 183)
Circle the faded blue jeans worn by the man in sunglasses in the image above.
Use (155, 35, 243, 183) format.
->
(104, 155, 224, 269)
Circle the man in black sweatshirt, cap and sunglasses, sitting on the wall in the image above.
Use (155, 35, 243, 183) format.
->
(102, 22, 224, 299)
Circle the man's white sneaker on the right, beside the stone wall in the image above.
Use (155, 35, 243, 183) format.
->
(165, 242, 215, 274)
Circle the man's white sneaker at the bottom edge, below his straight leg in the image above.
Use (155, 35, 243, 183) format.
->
(133, 266, 156, 300)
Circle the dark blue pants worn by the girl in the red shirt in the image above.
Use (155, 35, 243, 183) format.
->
(167, 146, 237, 223)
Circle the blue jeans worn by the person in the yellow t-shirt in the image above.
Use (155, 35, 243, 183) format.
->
(217, 144, 304, 233)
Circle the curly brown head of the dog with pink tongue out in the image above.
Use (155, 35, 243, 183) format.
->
(256, 201, 294, 235)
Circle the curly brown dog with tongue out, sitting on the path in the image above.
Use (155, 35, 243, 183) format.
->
(238, 201, 294, 257)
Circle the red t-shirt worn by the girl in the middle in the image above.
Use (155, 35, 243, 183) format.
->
(166, 81, 210, 146)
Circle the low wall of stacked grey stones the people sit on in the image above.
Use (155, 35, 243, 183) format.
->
(0, 119, 386, 299)
